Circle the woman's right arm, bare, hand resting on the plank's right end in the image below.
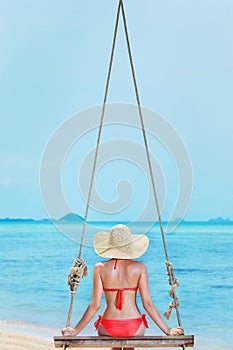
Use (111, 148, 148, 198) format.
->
(139, 264, 184, 335)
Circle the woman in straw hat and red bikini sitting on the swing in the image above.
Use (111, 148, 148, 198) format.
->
(62, 225, 184, 337)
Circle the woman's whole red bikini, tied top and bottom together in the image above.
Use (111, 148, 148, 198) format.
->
(94, 259, 149, 337)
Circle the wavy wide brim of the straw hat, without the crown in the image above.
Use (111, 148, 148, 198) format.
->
(94, 232, 149, 259)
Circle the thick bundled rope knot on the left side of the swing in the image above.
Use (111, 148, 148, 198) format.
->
(67, 257, 87, 296)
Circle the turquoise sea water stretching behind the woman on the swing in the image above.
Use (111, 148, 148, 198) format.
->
(0, 223, 233, 349)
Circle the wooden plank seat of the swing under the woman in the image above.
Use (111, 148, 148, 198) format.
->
(53, 335, 194, 348)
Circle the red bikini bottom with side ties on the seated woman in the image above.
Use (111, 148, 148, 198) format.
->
(94, 314, 149, 337)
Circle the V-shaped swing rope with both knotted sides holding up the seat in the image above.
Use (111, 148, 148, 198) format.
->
(66, 0, 184, 334)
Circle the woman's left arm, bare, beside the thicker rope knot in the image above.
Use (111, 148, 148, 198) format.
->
(61, 263, 103, 336)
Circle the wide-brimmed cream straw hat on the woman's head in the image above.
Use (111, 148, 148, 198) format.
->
(94, 224, 149, 259)
